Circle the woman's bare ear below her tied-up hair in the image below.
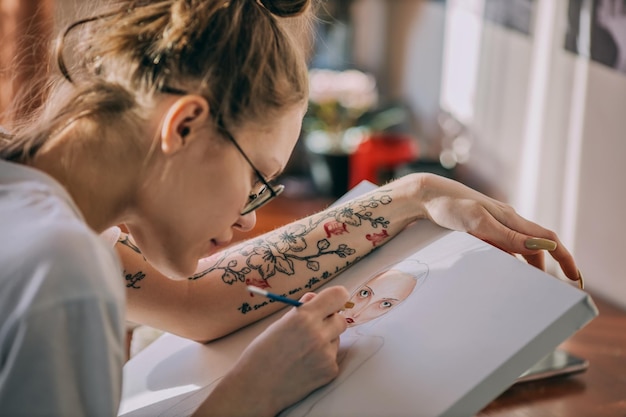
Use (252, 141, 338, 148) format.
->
(161, 95, 209, 155)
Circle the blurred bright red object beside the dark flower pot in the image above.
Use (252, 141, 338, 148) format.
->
(348, 133, 418, 189)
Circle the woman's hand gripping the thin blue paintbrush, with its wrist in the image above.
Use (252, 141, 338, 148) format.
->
(198, 287, 349, 416)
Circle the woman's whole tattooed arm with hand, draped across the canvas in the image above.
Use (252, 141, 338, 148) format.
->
(117, 174, 578, 341)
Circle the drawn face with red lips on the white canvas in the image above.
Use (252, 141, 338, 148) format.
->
(343, 269, 417, 327)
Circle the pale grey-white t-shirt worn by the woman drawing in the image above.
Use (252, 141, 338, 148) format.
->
(0, 160, 124, 416)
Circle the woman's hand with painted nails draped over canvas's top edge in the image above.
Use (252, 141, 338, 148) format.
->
(412, 175, 580, 281)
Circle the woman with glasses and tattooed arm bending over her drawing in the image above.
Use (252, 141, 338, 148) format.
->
(0, 0, 578, 416)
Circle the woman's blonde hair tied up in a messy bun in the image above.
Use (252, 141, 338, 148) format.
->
(0, 0, 313, 162)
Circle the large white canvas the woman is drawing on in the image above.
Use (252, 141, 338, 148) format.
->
(120, 182, 597, 417)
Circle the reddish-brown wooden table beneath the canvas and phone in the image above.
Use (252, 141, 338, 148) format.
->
(246, 196, 626, 417)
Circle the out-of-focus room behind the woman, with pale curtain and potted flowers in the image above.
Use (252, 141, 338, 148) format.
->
(0, 0, 626, 308)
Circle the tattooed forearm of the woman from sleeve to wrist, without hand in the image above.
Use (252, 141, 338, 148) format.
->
(120, 175, 422, 341)
